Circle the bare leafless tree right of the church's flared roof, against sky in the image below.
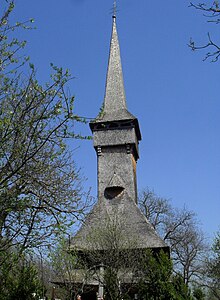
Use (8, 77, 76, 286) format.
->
(139, 189, 207, 284)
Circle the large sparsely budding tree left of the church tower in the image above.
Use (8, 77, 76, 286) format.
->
(0, 0, 90, 254)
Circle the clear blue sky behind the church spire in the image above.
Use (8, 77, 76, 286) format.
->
(10, 0, 220, 239)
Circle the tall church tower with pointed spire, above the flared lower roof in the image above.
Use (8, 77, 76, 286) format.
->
(90, 17, 141, 203)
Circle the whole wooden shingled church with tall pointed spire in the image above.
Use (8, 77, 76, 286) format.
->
(70, 15, 169, 300)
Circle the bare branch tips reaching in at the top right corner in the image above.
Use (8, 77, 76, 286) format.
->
(189, 1, 220, 62)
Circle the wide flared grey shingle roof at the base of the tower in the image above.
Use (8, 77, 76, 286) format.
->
(71, 192, 167, 251)
